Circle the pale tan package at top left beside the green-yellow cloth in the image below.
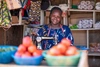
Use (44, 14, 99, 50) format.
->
(6, 0, 22, 10)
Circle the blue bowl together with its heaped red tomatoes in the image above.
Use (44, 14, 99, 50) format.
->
(13, 36, 43, 65)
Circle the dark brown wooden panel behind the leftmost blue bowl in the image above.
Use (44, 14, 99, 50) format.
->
(0, 25, 23, 45)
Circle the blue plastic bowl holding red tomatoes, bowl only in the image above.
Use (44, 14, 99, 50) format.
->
(12, 55, 43, 65)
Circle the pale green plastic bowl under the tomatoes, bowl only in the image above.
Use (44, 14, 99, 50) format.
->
(42, 51, 81, 67)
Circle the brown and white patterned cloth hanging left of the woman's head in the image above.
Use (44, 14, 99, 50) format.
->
(29, 0, 41, 22)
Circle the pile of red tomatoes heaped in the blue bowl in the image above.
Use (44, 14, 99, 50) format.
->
(15, 36, 42, 57)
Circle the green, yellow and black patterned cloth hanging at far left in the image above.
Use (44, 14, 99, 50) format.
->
(0, 0, 12, 28)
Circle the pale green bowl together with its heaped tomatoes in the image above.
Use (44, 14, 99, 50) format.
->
(43, 38, 81, 66)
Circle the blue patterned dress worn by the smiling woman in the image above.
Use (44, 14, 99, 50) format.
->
(38, 25, 74, 50)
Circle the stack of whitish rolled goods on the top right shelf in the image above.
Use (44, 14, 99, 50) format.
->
(78, 1, 94, 10)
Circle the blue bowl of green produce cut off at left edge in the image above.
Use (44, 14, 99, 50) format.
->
(0, 45, 17, 64)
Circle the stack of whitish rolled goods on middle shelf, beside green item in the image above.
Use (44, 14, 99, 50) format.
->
(77, 19, 93, 29)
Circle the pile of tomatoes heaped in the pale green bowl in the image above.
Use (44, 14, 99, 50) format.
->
(47, 38, 78, 56)
